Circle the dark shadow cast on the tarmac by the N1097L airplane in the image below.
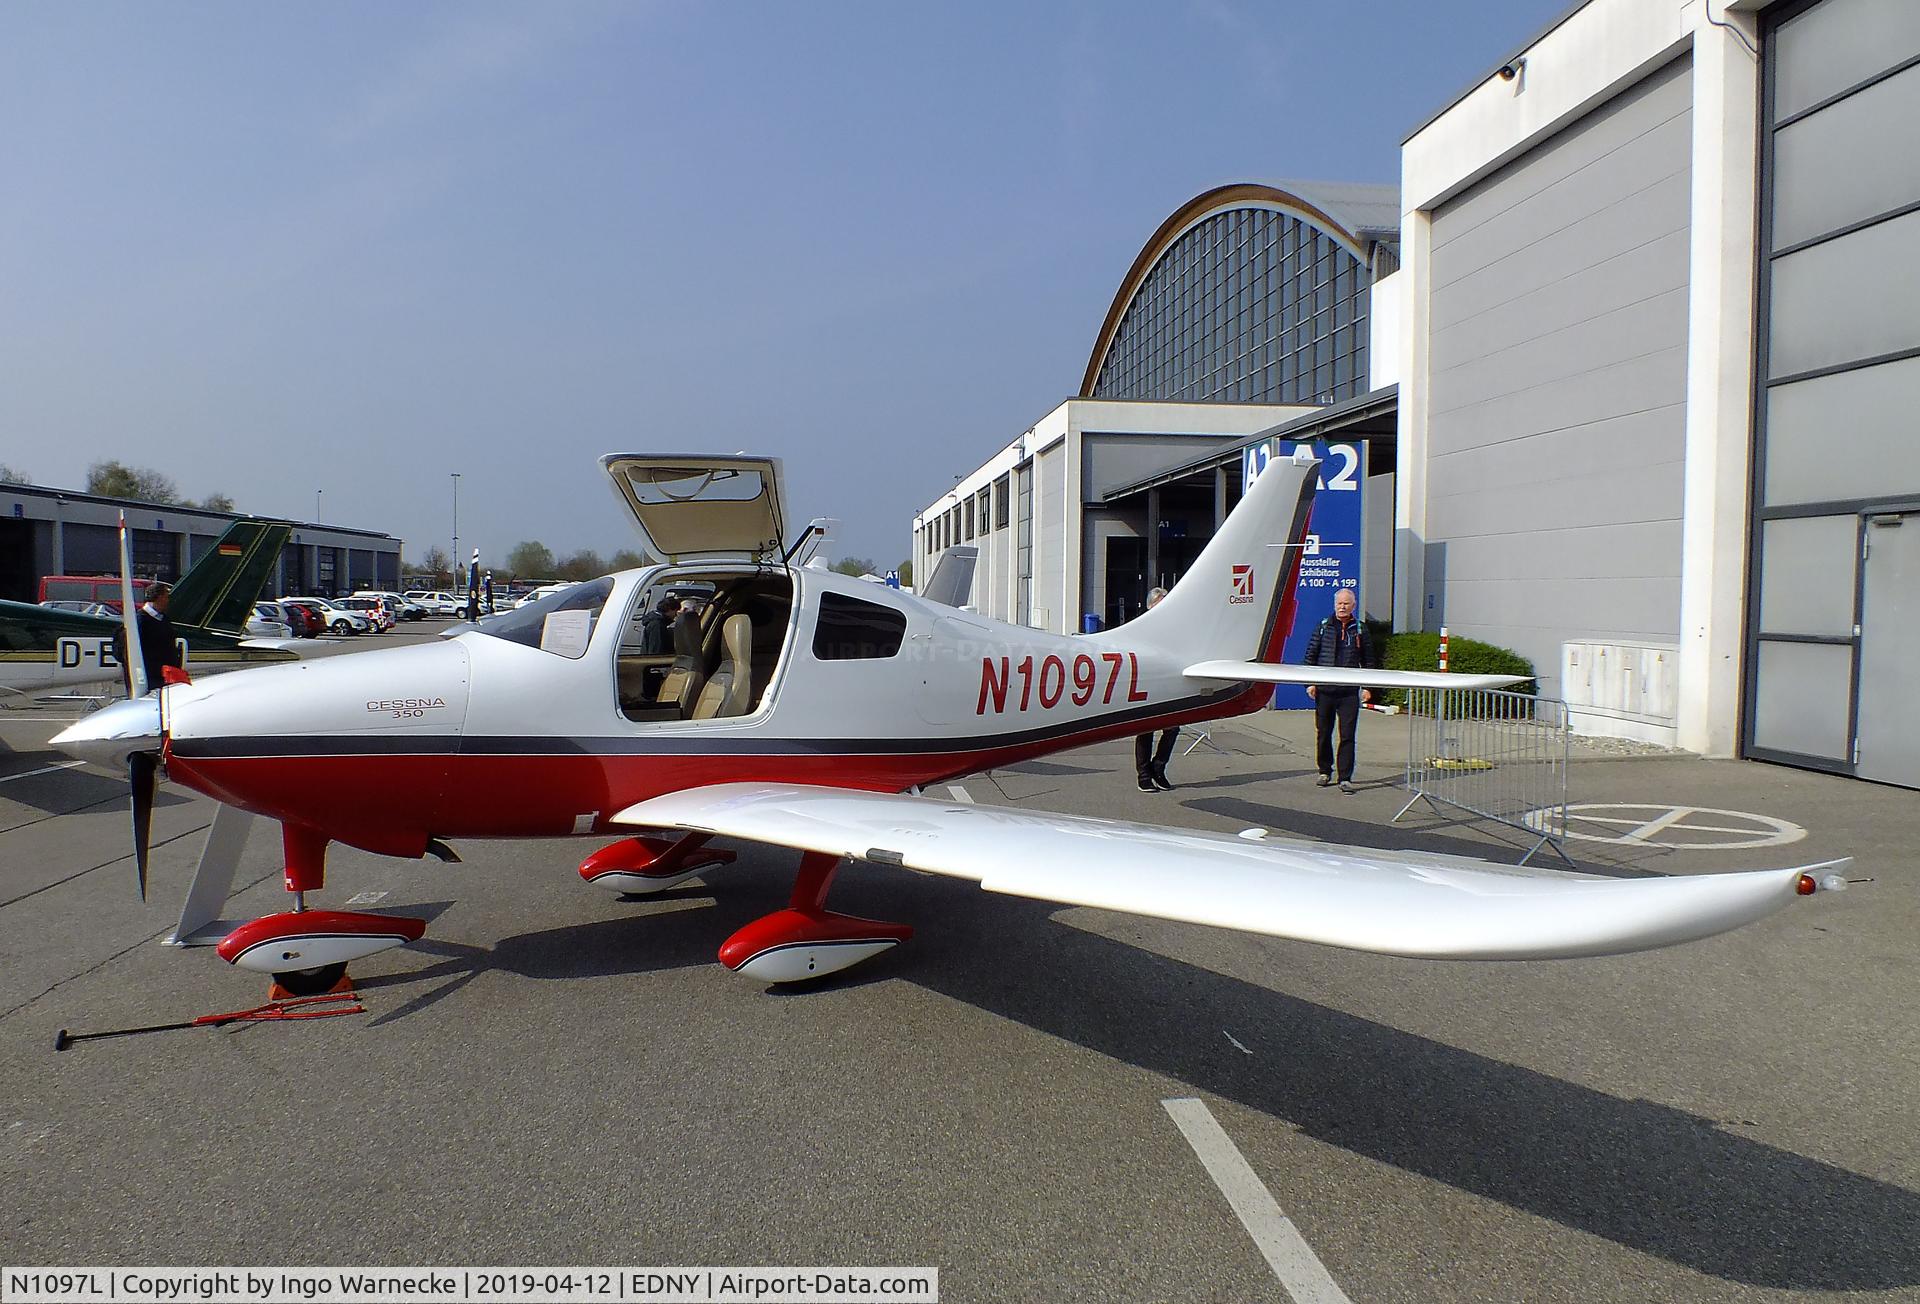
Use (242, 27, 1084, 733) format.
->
(349, 847, 1920, 1291)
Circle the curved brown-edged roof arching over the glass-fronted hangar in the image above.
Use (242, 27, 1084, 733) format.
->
(1081, 181, 1400, 398)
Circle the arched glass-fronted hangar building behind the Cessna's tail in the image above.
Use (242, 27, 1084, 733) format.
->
(912, 181, 1400, 632)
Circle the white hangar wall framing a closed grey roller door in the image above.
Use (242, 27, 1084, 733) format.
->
(1396, 0, 1759, 755)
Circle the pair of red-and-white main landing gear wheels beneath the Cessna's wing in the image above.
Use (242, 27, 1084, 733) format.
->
(580, 833, 914, 983)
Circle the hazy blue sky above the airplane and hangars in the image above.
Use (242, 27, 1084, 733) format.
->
(0, 0, 1565, 563)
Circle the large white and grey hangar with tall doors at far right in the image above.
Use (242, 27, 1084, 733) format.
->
(1396, 0, 1920, 785)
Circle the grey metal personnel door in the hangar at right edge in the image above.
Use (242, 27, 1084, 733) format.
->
(1855, 513, 1920, 787)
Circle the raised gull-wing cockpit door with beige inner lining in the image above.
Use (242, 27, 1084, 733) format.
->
(601, 453, 783, 563)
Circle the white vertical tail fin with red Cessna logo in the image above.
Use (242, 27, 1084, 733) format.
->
(1121, 447, 1319, 661)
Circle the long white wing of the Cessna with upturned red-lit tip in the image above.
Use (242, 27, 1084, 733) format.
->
(612, 784, 1847, 960)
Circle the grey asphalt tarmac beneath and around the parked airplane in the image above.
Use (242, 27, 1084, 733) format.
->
(0, 636, 1920, 1302)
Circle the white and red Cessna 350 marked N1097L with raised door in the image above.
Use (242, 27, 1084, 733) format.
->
(54, 455, 1843, 995)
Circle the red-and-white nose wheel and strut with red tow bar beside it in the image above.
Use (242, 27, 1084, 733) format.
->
(215, 824, 426, 999)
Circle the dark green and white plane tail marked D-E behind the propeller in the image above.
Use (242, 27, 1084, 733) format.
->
(0, 520, 296, 695)
